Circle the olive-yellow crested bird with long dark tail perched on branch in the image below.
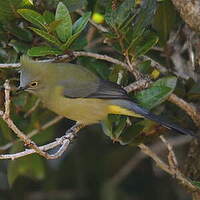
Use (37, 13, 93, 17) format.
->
(19, 55, 195, 136)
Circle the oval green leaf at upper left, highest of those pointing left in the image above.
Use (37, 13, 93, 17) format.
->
(17, 9, 47, 29)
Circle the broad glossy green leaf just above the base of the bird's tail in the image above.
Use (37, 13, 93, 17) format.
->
(135, 76, 177, 110)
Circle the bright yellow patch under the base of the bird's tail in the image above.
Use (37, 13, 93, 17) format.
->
(108, 105, 142, 118)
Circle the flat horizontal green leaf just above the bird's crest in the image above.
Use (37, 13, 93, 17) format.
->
(27, 46, 62, 56)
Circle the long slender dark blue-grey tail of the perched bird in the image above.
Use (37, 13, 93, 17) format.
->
(113, 100, 198, 137)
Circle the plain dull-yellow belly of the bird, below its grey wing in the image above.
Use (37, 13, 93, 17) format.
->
(45, 97, 109, 125)
